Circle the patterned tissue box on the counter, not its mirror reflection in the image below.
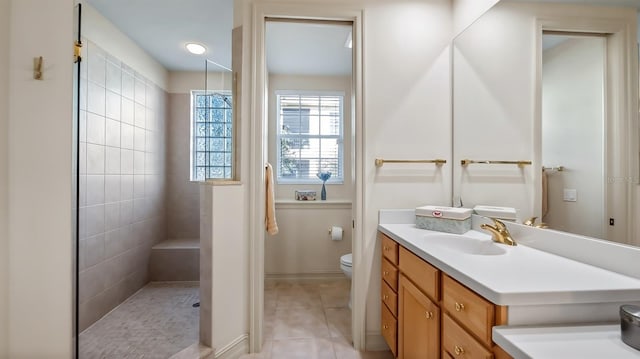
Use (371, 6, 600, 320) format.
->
(416, 206, 472, 234)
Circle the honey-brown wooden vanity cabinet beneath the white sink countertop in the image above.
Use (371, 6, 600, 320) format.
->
(378, 232, 509, 359)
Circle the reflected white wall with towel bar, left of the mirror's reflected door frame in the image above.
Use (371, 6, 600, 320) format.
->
(453, 3, 537, 218)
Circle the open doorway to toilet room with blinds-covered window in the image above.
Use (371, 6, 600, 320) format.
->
(264, 18, 353, 357)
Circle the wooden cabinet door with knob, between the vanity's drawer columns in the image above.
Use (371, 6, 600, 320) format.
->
(398, 275, 440, 359)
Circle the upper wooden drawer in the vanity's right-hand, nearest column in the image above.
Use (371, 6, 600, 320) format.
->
(442, 275, 495, 347)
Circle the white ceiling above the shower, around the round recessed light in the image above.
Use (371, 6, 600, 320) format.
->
(87, 0, 233, 71)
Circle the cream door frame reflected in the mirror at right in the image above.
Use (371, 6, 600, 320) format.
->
(533, 14, 640, 245)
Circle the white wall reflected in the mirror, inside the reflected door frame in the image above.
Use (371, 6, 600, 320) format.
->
(542, 37, 605, 238)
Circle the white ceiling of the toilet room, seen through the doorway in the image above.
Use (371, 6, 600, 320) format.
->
(265, 21, 352, 76)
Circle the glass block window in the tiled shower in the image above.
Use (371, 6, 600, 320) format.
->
(191, 91, 233, 181)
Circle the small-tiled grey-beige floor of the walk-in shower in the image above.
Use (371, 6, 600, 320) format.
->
(79, 282, 199, 359)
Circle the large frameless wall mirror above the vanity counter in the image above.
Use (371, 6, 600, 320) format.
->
(452, 0, 640, 245)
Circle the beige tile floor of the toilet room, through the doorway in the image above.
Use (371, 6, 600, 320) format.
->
(241, 279, 393, 359)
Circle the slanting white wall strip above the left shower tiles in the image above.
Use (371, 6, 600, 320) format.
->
(81, 1, 169, 90)
